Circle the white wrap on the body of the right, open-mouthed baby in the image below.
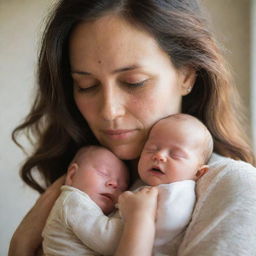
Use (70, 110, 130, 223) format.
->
(153, 180, 196, 255)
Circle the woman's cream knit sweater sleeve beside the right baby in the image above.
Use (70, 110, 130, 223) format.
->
(177, 156, 256, 256)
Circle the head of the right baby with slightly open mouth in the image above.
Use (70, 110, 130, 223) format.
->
(138, 114, 213, 186)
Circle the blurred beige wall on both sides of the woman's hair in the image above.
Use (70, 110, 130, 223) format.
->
(0, 0, 255, 255)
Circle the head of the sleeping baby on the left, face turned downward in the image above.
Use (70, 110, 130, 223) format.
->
(66, 146, 129, 214)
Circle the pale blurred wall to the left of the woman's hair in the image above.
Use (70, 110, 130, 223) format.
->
(0, 0, 54, 255)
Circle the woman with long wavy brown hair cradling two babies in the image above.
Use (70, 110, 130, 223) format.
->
(9, 0, 256, 256)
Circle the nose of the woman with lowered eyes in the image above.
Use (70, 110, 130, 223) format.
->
(101, 84, 125, 121)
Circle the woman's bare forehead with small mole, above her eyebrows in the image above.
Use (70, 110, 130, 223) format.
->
(70, 14, 167, 70)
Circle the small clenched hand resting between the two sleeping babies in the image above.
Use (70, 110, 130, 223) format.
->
(118, 187, 158, 222)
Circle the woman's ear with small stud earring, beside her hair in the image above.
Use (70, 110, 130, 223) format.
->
(179, 67, 196, 96)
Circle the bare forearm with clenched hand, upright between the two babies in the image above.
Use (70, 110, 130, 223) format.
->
(115, 187, 158, 256)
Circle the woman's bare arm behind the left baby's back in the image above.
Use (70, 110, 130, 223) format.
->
(8, 176, 65, 256)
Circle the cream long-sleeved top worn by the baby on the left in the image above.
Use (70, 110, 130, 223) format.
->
(42, 186, 123, 256)
